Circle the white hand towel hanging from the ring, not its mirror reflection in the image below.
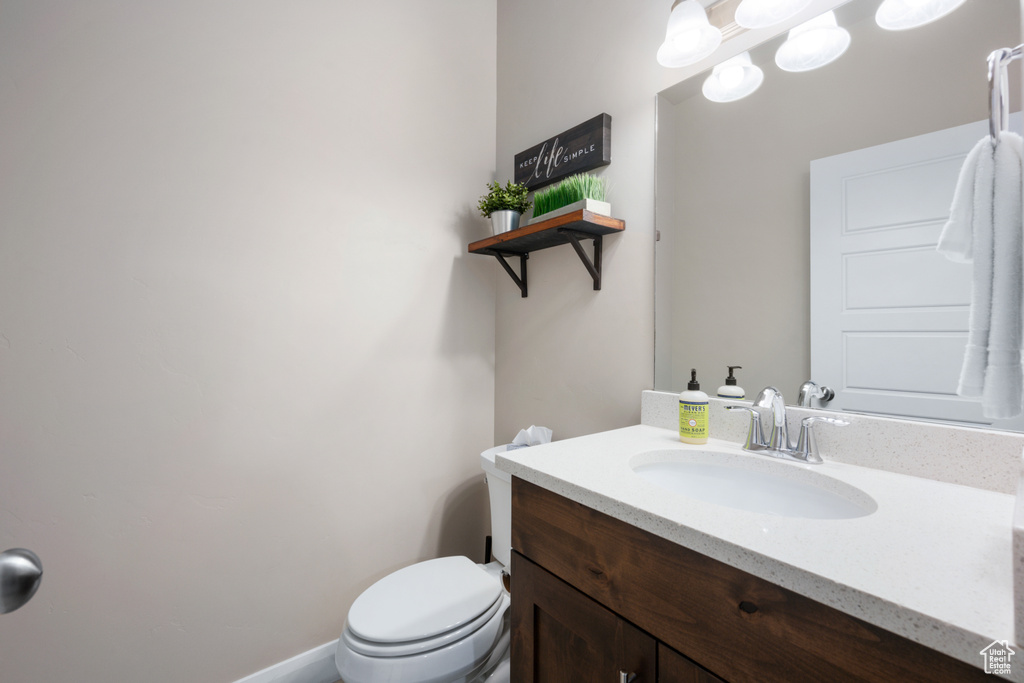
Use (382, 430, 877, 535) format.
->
(975, 133, 1024, 419)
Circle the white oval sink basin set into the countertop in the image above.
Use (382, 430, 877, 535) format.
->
(630, 450, 879, 519)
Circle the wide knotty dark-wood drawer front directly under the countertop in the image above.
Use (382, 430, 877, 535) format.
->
(512, 478, 991, 683)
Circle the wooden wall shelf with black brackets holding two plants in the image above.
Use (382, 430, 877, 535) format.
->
(469, 209, 626, 297)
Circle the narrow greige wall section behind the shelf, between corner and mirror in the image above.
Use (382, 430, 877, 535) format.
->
(495, 0, 692, 441)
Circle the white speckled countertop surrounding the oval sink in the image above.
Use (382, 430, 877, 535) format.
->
(497, 425, 1024, 681)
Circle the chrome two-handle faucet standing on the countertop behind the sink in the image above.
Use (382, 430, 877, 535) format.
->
(725, 386, 850, 465)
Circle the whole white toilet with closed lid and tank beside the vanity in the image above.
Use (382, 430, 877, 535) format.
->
(335, 445, 512, 683)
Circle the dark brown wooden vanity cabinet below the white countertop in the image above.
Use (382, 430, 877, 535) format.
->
(512, 478, 991, 683)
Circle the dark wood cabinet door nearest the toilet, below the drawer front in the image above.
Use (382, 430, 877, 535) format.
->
(511, 552, 656, 683)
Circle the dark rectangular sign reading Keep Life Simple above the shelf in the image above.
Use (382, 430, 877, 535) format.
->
(515, 114, 611, 189)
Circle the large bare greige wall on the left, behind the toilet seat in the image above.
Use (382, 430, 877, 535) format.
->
(0, 0, 496, 683)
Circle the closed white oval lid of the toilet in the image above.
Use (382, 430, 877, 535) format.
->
(348, 556, 501, 643)
